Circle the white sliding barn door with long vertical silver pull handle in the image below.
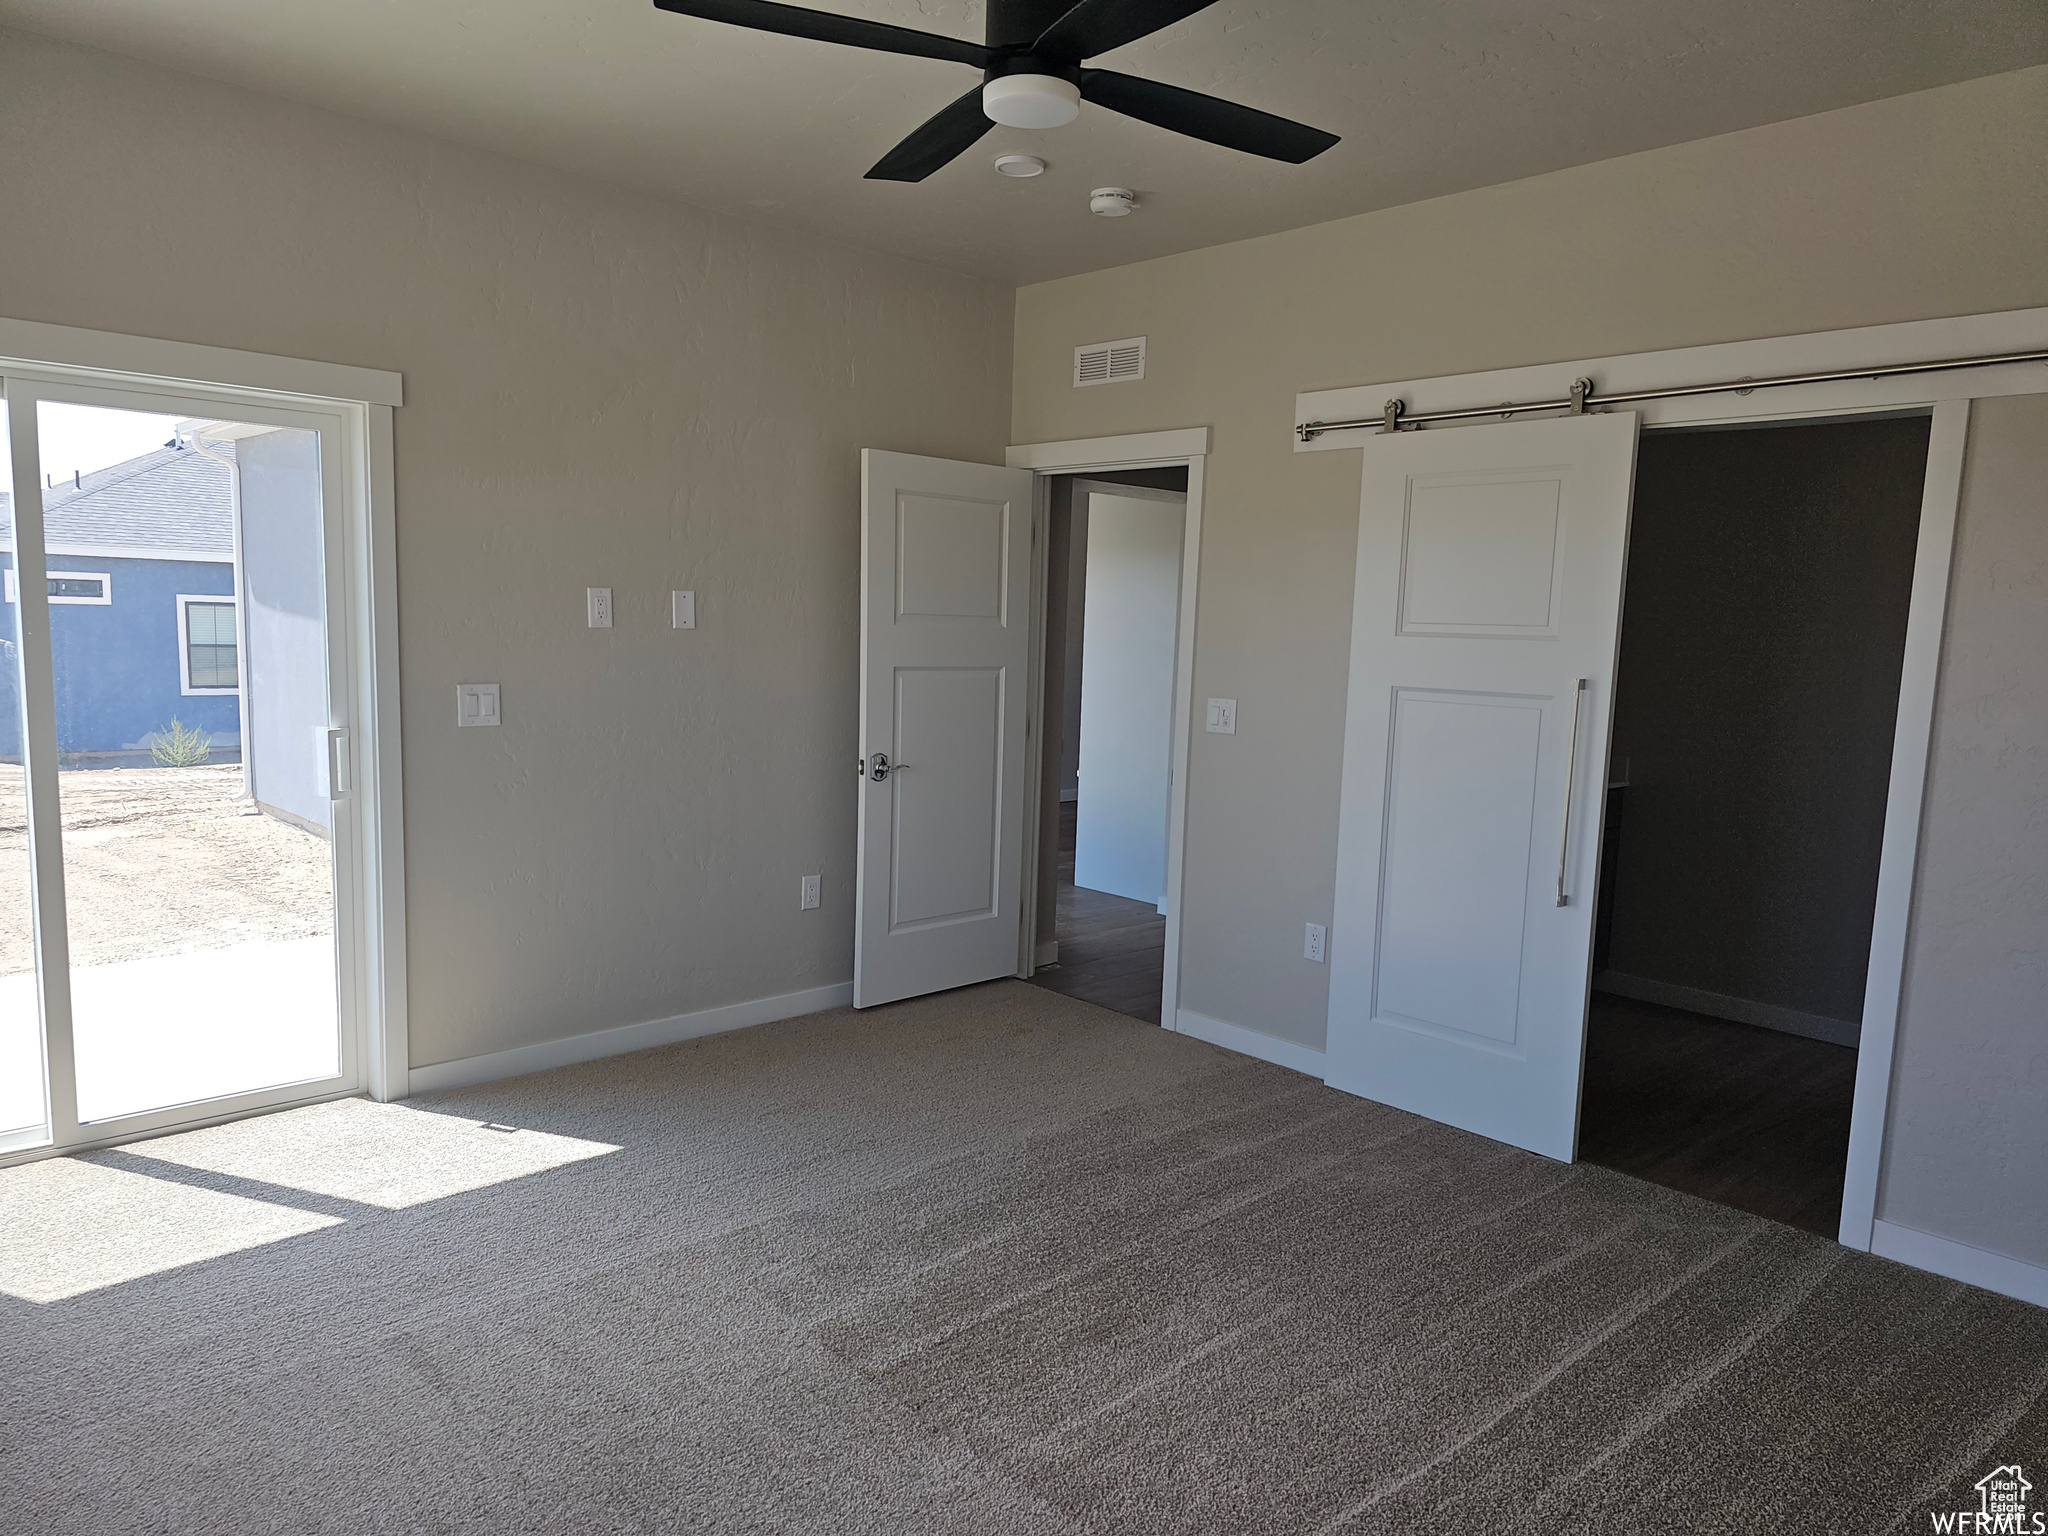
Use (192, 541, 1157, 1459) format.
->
(1325, 412, 1636, 1159)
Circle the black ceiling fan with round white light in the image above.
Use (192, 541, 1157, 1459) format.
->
(653, 0, 1337, 182)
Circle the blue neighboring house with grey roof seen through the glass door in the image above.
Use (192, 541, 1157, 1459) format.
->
(0, 436, 242, 766)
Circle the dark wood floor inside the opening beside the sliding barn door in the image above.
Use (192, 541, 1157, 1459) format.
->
(1579, 993, 1855, 1237)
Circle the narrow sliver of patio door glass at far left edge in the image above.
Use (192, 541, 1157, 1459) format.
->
(0, 401, 49, 1149)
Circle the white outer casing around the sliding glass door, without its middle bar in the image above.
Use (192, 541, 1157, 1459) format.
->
(0, 317, 410, 1163)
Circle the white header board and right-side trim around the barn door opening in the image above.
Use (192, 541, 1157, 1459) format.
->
(1294, 307, 2048, 1249)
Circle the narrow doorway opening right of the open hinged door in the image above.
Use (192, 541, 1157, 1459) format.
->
(1030, 467, 1188, 1024)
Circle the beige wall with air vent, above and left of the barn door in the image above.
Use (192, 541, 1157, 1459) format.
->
(1012, 68, 2048, 1047)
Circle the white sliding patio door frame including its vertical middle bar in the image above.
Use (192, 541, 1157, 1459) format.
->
(0, 319, 408, 1163)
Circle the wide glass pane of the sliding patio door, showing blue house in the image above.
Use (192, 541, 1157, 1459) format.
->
(37, 399, 342, 1122)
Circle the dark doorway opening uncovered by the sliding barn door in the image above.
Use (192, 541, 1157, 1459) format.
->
(1579, 416, 1929, 1237)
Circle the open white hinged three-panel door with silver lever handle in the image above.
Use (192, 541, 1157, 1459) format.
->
(854, 449, 1032, 1008)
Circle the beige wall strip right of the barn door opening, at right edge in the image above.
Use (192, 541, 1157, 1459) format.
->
(1878, 395, 2048, 1266)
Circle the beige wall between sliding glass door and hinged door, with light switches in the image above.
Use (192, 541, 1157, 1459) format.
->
(0, 33, 1012, 1063)
